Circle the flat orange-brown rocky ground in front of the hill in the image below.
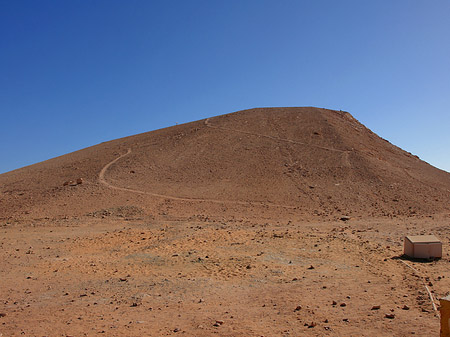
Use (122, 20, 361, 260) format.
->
(0, 212, 450, 336)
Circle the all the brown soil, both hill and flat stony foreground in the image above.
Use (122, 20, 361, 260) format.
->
(0, 108, 450, 336)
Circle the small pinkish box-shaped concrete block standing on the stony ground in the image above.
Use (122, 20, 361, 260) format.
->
(403, 235, 442, 259)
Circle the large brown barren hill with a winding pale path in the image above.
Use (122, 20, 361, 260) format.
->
(0, 107, 450, 219)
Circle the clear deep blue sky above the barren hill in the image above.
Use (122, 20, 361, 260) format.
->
(0, 0, 450, 173)
